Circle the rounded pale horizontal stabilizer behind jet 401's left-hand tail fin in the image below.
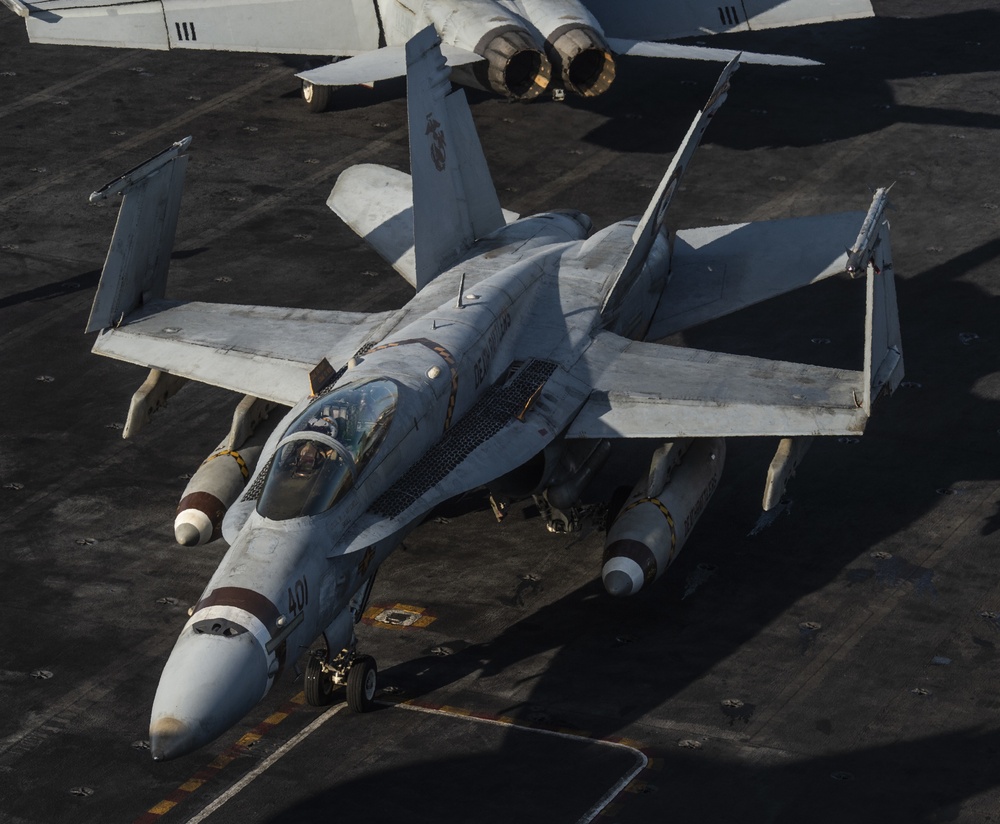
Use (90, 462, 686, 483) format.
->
(326, 163, 517, 287)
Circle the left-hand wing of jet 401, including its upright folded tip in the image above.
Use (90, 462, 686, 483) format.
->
(87, 138, 400, 405)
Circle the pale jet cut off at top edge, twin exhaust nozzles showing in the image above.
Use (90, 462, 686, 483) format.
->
(0, 0, 873, 111)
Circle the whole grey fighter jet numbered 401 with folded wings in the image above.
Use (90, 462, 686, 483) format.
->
(87, 27, 903, 760)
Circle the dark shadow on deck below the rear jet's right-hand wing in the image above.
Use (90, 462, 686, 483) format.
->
(562, 11, 1000, 153)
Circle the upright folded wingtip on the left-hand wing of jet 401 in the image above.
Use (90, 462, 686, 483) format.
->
(87, 137, 191, 332)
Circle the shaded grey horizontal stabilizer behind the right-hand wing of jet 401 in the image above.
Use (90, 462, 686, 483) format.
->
(646, 212, 864, 340)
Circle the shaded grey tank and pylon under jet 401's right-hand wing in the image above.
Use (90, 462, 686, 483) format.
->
(601, 438, 726, 596)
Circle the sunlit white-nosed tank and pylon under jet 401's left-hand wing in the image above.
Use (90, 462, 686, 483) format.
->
(174, 395, 281, 546)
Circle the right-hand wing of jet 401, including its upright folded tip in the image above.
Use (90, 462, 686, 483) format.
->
(567, 189, 903, 439)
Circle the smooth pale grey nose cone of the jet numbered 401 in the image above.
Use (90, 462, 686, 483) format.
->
(149, 624, 270, 761)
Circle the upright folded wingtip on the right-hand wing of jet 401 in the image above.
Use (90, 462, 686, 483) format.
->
(847, 188, 903, 414)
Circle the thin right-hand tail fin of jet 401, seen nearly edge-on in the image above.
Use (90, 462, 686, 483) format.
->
(605, 54, 740, 307)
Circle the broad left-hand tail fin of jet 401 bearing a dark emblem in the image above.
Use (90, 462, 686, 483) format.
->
(406, 26, 505, 291)
